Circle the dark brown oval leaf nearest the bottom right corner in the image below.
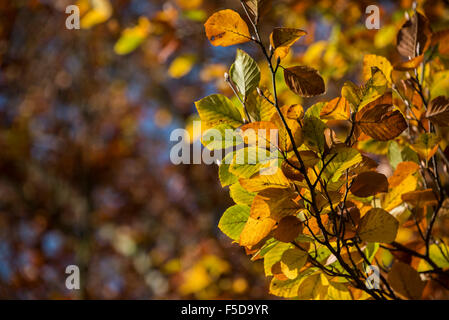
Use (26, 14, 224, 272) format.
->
(388, 261, 425, 299)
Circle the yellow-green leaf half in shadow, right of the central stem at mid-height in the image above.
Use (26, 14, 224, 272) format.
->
(324, 148, 362, 182)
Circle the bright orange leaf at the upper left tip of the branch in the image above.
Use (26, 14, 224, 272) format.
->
(204, 9, 251, 47)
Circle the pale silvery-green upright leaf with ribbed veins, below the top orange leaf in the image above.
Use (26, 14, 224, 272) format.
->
(229, 49, 260, 100)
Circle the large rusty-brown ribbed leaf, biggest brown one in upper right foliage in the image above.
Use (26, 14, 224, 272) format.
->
(356, 93, 407, 141)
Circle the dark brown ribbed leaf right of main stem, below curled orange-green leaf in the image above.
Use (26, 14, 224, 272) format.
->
(284, 66, 326, 97)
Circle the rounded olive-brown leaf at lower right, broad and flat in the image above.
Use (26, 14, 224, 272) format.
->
(357, 208, 399, 243)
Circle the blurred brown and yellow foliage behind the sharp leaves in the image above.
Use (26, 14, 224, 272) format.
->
(0, 0, 449, 299)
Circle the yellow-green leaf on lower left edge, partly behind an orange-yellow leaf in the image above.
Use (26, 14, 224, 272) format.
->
(218, 204, 250, 241)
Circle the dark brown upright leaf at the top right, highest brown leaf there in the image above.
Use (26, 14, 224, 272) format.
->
(397, 12, 432, 59)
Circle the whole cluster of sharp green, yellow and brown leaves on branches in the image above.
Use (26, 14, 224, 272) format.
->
(196, 0, 449, 299)
